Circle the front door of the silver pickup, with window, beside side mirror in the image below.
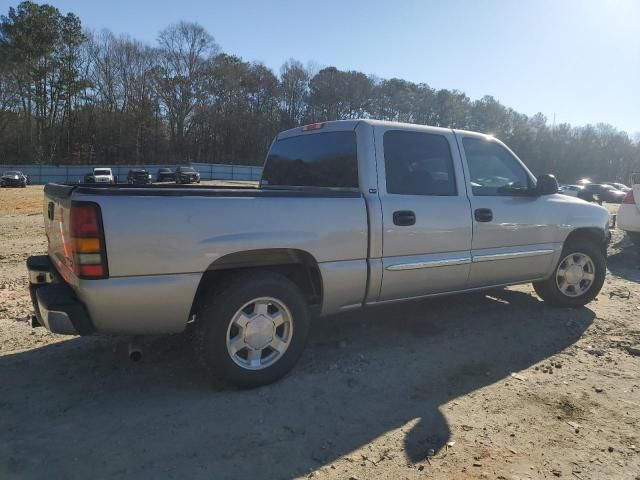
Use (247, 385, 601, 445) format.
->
(456, 132, 562, 288)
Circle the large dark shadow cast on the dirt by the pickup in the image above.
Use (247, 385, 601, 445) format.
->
(0, 290, 594, 479)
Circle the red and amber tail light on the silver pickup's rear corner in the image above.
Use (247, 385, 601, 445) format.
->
(69, 202, 109, 279)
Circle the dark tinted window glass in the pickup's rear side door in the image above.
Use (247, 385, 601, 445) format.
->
(383, 130, 457, 196)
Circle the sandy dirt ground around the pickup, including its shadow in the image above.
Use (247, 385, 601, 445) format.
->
(0, 186, 640, 480)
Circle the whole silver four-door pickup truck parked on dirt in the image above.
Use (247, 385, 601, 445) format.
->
(27, 120, 609, 387)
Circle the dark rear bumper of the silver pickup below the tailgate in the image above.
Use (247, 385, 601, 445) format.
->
(27, 255, 94, 335)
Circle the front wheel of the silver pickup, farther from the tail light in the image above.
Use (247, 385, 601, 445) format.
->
(533, 239, 607, 307)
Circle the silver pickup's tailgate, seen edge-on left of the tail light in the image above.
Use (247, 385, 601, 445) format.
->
(43, 183, 75, 281)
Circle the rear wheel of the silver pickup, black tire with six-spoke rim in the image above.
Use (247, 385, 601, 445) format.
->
(194, 272, 310, 388)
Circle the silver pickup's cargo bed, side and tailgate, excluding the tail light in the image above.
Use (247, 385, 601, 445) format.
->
(44, 184, 369, 333)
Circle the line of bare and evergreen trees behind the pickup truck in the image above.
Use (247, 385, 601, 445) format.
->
(0, 1, 640, 181)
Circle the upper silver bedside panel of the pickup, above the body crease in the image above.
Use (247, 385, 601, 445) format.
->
(74, 195, 367, 277)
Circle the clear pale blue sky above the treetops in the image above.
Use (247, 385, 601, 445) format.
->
(6, 0, 640, 135)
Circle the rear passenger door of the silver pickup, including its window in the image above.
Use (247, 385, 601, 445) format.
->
(375, 126, 471, 301)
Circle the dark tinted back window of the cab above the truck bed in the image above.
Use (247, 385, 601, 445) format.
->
(261, 131, 358, 189)
